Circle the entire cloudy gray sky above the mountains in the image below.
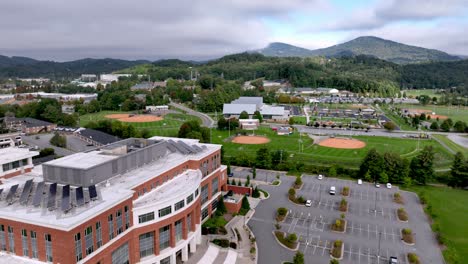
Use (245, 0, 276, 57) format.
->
(0, 0, 468, 61)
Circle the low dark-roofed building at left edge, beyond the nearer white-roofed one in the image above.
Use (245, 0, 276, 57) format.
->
(3, 117, 57, 134)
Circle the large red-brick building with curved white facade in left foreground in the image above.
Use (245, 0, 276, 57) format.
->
(0, 137, 227, 264)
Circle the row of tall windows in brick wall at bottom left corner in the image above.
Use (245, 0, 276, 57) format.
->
(0, 225, 53, 262)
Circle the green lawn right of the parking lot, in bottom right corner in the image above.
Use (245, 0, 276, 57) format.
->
(409, 186, 468, 263)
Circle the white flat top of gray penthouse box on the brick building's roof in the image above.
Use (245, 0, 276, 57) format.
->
(47, 150, 120, 169)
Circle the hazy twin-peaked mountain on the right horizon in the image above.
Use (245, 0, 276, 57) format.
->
(256, 36, 460, 64)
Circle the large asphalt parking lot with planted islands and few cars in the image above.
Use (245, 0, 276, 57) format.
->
(249, 175, 443, 264)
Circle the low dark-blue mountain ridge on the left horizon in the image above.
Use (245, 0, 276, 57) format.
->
(0, 56, 150, 78)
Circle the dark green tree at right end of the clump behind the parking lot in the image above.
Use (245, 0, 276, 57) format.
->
(409, 146, 434, 185)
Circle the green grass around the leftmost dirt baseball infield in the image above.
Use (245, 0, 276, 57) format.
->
(80, 111, 199, 137)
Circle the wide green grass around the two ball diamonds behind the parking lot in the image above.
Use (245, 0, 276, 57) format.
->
(212, 127, 452, 168)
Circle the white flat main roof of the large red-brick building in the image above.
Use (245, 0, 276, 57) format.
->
(0, 137, 221, 230)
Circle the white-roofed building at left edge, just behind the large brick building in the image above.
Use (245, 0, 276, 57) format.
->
(0, 147, 39, 179)
